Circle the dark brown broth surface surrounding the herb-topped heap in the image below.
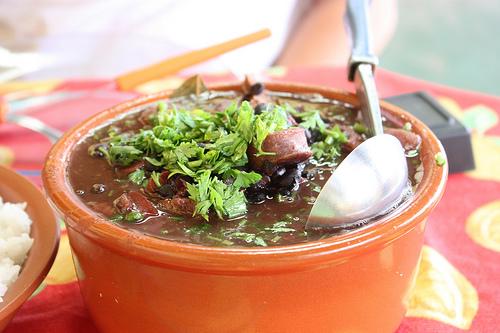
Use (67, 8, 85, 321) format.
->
(68, 92, 422, 246)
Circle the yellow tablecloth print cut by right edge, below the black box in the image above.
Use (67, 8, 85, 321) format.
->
(465, 200, 500, 252)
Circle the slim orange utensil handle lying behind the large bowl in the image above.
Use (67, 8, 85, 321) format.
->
(116, 29, 271, 90)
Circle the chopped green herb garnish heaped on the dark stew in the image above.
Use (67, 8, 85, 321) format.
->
(94, 101, 347, 220)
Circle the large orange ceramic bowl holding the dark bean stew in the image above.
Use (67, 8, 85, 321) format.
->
(43, 83, 447, 333)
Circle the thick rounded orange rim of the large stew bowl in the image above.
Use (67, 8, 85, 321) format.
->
(42, 82, 448, 273)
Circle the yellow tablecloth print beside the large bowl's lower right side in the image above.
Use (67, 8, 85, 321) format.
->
(406, 245, 479, 330)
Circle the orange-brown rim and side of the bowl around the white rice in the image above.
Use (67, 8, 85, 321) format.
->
(0, 166, 59, 332)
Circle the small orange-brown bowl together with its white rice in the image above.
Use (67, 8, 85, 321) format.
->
(0, 166, 59, 332)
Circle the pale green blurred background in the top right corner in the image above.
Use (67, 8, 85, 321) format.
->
(380, 0, 500, 95)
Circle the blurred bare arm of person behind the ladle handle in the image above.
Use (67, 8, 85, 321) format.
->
(277, 0, 397, 66)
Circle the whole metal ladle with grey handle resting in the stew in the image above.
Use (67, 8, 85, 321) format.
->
(306, 0, 408, 229)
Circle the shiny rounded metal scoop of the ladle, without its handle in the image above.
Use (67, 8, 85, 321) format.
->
(306, 134, 408, 229)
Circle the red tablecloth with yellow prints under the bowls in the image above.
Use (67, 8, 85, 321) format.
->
(0, 68, 500, 333)
